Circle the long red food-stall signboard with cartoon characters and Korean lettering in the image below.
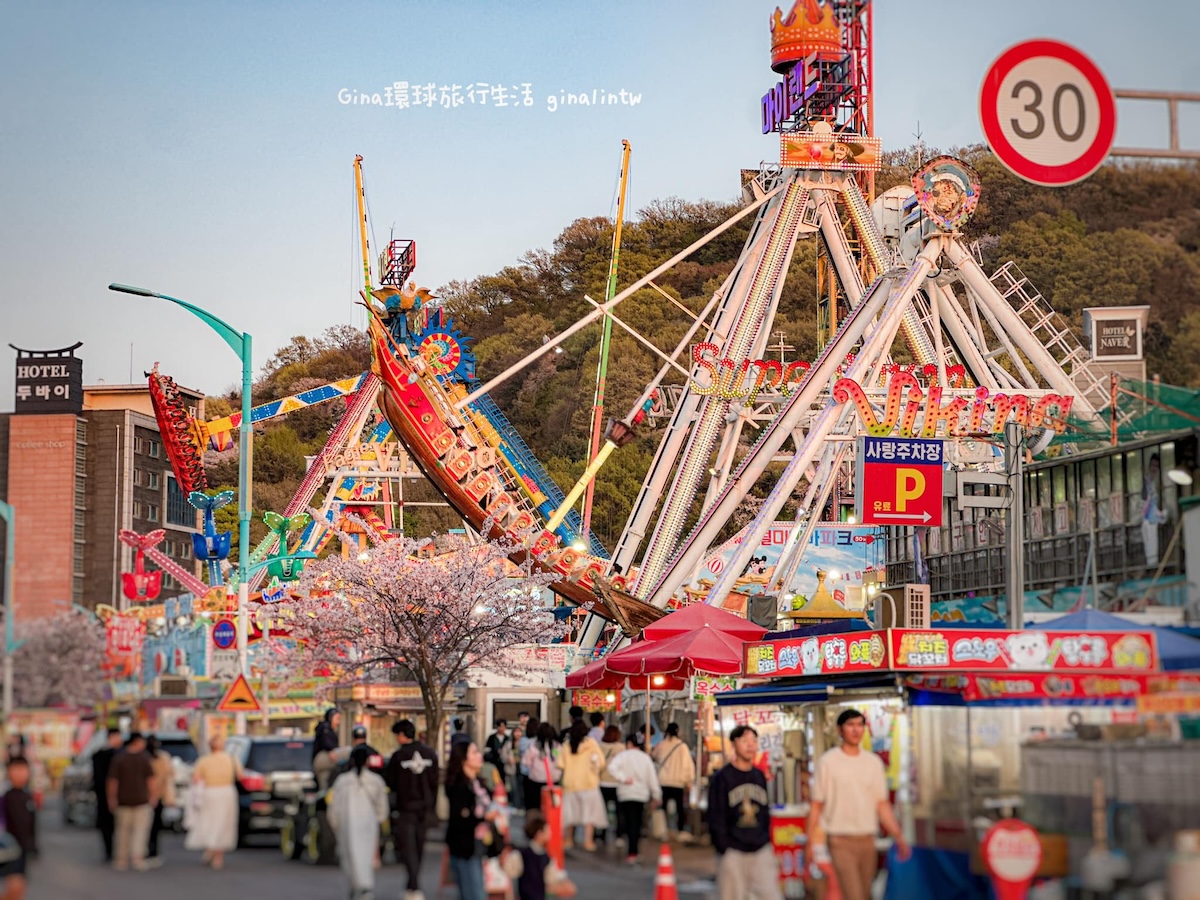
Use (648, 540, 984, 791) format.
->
(744, 629, 1170, 681)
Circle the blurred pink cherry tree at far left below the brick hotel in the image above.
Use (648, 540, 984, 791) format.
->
(12, 610, 104, 708)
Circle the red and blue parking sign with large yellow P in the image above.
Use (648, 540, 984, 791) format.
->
(854, 437, 943, 528)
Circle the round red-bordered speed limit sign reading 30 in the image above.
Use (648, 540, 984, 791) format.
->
(979, 40, 1117, 186)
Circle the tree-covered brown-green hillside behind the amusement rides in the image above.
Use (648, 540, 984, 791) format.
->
(201, 146, 1200, 556)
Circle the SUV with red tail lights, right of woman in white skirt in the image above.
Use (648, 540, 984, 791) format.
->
(226, 736, 317, 845)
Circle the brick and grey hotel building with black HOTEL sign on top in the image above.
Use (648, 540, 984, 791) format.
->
(0, 344, 204, 622)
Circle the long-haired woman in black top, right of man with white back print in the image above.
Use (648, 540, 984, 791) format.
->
(445, 742, 500, 900)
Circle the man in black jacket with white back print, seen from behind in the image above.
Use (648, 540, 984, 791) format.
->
(384, 719, 438, 900)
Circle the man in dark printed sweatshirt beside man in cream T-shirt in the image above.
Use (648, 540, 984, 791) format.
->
(708, 725, 784, 900)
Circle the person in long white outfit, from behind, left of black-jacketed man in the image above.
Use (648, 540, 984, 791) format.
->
(329, 746, 389, 900)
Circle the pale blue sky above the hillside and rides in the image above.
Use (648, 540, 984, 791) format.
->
(0, 0, 1200, 410)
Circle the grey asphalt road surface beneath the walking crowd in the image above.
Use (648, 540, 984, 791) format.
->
(29, 810, 715, 900)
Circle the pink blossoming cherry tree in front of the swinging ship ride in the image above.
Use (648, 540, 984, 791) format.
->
(292, 535, 563, 739)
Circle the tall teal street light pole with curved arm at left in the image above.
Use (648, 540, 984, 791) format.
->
(108, 284, 254, 734)
